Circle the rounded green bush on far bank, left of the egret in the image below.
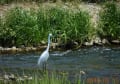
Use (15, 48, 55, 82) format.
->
(5, 7, 40, 46)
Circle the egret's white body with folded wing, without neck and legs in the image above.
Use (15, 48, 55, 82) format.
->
(38, 51, 49, 66)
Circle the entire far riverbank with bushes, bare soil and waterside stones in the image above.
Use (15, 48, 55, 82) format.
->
(0, 2, 120, 54)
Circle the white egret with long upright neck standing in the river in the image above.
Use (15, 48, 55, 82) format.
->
(38, 34, 52, 70)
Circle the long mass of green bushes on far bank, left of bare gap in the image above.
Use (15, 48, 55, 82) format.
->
(0, 6, 90, 47)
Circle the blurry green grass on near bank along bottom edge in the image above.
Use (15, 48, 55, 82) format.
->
(0, 71, 81, 84)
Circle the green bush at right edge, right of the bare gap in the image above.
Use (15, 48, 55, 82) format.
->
(99, 2, 120, 40)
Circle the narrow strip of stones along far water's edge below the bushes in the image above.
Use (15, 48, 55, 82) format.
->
(0, 39, 120, 54)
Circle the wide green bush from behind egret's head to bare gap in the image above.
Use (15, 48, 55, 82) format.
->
(38, 7, 90, 44)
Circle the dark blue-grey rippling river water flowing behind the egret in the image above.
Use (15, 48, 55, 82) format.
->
(0, 46, 120, 80)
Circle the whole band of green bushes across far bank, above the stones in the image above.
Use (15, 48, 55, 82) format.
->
(0, 2, 120, 48)
